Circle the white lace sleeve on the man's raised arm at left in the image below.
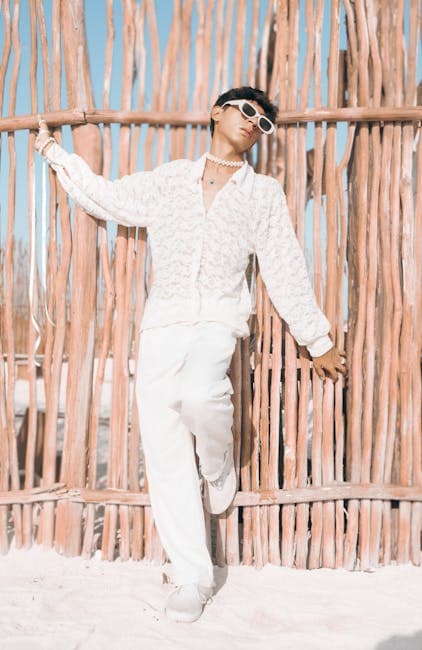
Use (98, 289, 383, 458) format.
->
(45, 143, 156, 226)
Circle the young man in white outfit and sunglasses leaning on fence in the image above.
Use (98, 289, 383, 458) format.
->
(36, 87, 345, 621)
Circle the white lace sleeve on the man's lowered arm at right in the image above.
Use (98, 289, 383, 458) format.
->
(255, 182, 333, 357)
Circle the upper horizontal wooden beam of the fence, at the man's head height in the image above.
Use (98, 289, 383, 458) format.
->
(0, 106, 422, 132)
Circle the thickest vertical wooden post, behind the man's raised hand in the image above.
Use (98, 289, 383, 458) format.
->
(57, 0, 101, 555)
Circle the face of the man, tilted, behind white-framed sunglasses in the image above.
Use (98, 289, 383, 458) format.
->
(211, 100, 264, 153)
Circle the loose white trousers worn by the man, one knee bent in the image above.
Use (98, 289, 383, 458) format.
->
(136, 322, 236, 586)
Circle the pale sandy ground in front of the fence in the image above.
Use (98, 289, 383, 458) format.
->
(0, 547, 422, 650)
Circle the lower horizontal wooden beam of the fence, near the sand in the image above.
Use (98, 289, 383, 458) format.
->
(0, 483, 422, 507)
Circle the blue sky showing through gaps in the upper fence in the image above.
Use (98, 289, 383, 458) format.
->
(0, 0, 345, 242)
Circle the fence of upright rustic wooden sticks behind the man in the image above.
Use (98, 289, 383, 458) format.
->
(0, 0, 422, 569)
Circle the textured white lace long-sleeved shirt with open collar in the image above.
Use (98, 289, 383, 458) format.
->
(46, 144, 333, 356)
